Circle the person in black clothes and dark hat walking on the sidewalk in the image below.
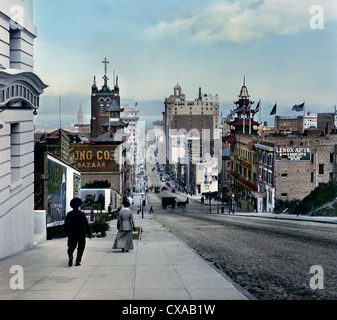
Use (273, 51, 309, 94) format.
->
(64, 198, 92, 267)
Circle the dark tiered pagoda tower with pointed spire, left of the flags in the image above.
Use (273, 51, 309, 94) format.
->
(227, 77, 259, 135)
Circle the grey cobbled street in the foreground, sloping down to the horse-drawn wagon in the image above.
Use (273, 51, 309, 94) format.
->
(148, 165, 337, 300)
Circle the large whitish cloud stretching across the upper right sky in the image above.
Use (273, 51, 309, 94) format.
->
(147, 0, 337, 43)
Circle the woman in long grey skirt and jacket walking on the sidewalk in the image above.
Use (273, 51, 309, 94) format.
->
(112, 198, 135, 252)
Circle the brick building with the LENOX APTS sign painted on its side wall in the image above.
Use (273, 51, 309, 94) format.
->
(255, 134, 337, 212)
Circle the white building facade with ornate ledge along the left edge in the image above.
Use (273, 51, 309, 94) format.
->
(0, 0, 47, 259)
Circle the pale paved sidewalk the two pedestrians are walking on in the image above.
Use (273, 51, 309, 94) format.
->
(0, 214, 249, 300)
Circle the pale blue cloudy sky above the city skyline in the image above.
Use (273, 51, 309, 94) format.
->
(34, 0, 337, 126)
